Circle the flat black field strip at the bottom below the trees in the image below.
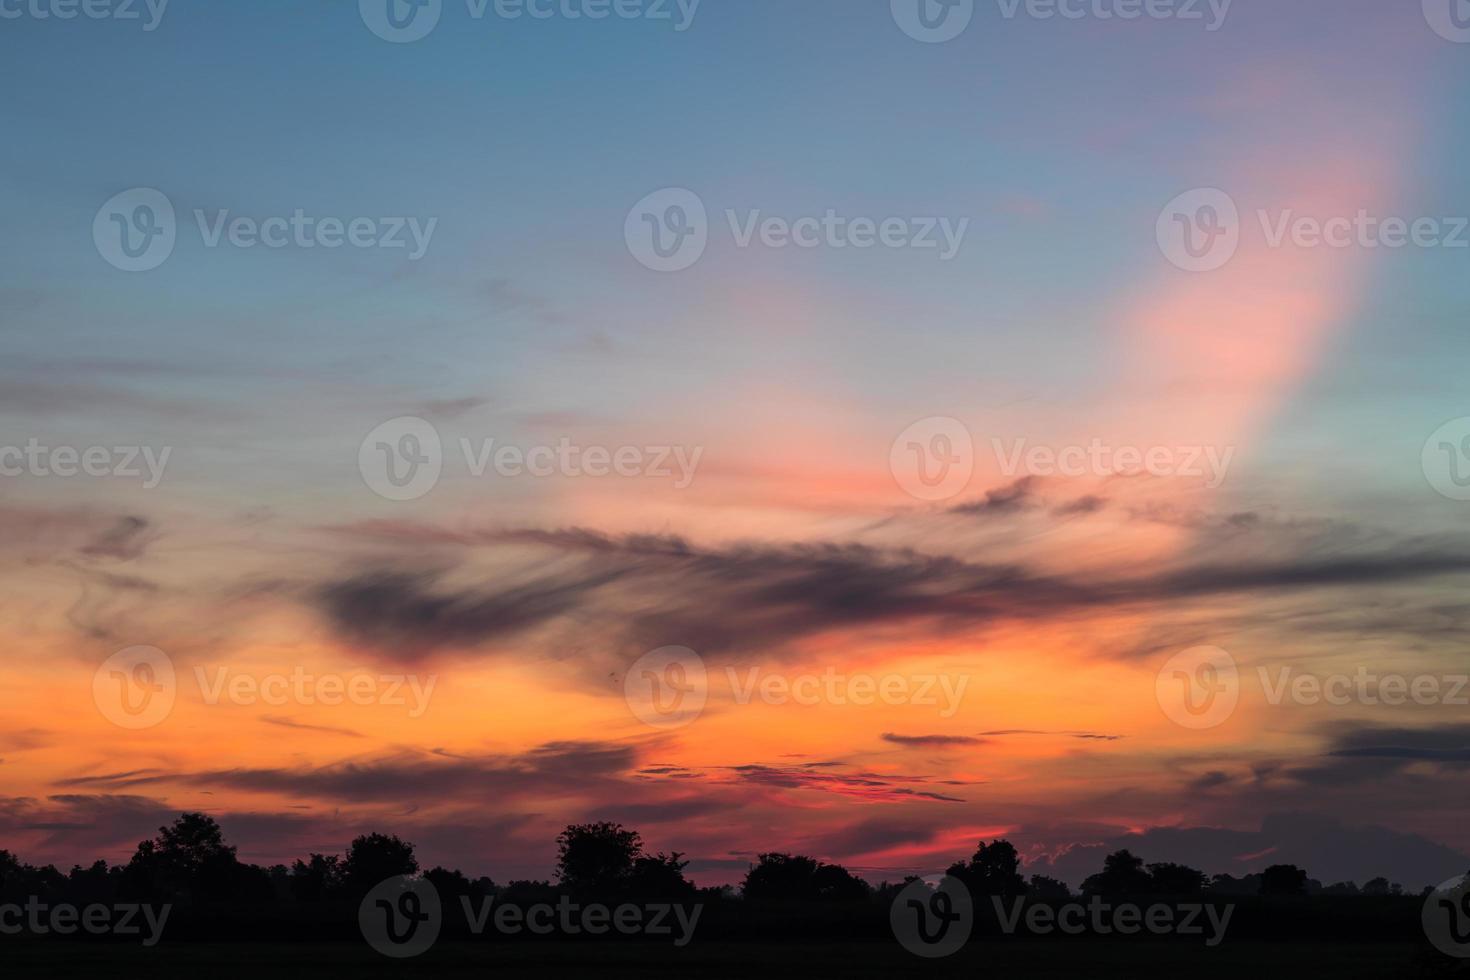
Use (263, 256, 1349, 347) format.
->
(0, 939, 1470, 980)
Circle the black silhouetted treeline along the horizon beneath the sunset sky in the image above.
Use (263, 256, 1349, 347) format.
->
(0, 813, 1452, 939)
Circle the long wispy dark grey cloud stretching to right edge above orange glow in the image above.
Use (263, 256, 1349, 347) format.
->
(309, 525, 1470, 660)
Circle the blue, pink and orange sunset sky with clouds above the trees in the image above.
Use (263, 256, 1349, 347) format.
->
(0, 0, 1470, 887)
